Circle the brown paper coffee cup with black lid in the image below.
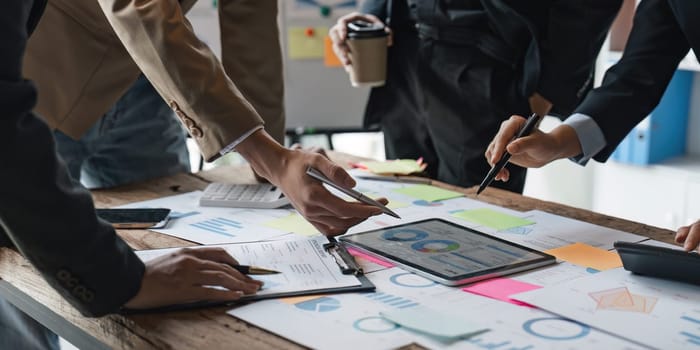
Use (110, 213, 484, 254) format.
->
(346, 22, 388, 87)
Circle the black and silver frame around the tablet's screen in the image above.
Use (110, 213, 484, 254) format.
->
(340, 218, 556, 286)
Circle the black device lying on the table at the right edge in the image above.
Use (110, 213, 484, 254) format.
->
(615, 241, 700, 284)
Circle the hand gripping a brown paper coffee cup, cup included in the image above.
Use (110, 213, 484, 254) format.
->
(330, 13, 391, 87)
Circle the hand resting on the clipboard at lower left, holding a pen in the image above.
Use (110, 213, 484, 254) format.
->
(124, 248, 263, 309)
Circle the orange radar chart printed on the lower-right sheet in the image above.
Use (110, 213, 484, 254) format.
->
(588, 287, 658, 314)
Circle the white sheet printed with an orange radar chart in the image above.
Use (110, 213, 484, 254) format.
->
(514, 269, 700, 349)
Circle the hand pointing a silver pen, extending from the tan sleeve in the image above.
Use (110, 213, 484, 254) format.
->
(236, 131, 388, 236)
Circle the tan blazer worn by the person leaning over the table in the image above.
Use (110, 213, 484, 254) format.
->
(24, 0, 284, 160)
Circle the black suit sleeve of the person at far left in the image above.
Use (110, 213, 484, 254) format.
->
(0, 0, 144, 316)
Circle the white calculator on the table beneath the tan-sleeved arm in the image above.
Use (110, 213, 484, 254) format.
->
(199, 182, 289, 209)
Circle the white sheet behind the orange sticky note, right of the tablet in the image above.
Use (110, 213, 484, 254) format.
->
(476, 209, 646, 251)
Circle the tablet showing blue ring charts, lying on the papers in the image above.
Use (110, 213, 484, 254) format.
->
(340, 219, 556, 286)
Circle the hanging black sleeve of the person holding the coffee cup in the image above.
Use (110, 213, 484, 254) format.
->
(537, 0, 622, 115)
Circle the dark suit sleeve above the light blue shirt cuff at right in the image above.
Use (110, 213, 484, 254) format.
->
(576, 0, 690, 162)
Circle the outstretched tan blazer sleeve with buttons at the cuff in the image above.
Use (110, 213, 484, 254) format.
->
(98, 0, 276, 160)
